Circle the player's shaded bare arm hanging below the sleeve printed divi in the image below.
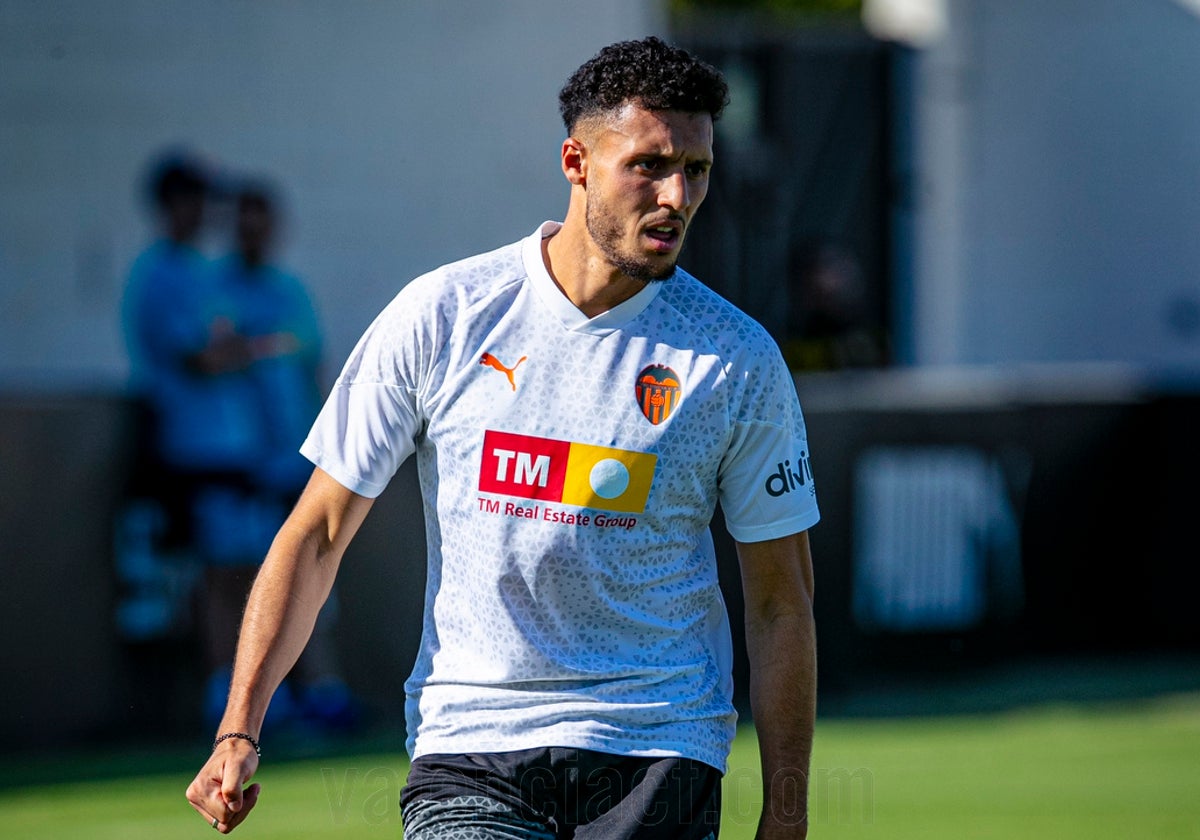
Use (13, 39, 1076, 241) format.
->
(737, 532, 817, 840)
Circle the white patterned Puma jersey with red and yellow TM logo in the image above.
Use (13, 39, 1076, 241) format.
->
(302, 222, 818, 769)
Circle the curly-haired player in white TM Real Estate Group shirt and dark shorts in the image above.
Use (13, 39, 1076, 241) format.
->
(188, 38, 817, 840)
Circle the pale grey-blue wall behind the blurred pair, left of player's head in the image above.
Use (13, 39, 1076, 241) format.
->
(0, 0, 662, 390)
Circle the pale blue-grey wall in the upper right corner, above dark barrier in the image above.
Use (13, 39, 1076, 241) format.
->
(899, 0, 1200, 377)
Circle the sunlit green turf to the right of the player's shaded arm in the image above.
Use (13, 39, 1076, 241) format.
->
(787, 695, 1200, 840)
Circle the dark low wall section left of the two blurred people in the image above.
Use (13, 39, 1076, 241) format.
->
(0, 397, 128, 745)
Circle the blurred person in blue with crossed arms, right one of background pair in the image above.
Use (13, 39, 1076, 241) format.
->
(194, 182, 354, 728)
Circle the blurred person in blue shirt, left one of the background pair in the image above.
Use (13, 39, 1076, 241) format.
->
(116, 150, 223, 619)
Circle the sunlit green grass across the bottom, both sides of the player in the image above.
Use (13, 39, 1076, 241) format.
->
(0, 694, 1200, 840)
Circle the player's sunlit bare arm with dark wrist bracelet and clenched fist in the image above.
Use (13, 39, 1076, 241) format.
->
(187, 469, 372, 834)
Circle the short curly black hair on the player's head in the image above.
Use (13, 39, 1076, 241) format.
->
(558, 36, 730, 134)
